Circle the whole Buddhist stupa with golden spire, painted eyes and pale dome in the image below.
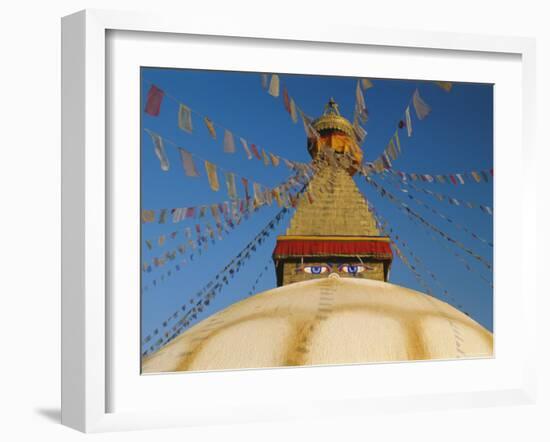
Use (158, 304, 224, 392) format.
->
(142, 99, 493, 373)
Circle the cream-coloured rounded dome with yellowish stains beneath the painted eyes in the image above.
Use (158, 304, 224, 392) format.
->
(142, 277, 493, 373)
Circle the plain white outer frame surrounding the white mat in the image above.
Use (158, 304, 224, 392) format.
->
(62, 10, 537, 432)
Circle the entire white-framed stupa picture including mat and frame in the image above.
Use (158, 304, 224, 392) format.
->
(62, 11, 536, 432)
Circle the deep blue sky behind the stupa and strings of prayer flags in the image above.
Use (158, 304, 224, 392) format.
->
(141, 68, 493, 350)
